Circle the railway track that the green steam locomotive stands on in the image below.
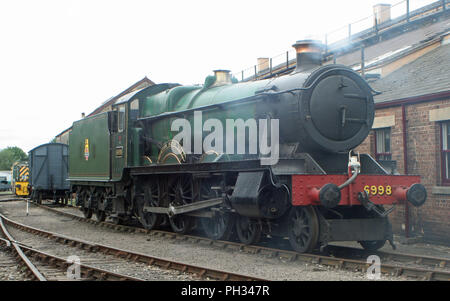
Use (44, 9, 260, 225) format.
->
(27, 200, 450, 281)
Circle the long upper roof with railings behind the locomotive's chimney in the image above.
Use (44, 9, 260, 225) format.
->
(241, 1, 450, 81)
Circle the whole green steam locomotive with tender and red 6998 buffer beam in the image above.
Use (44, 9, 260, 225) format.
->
(69, 40, 426, 252)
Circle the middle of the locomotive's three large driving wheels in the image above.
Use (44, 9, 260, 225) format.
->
(168, 177, 194, 234)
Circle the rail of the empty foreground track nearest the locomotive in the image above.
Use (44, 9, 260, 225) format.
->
(0, 214, 268, 281)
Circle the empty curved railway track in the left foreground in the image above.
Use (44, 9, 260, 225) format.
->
(0, 211, 266, 281)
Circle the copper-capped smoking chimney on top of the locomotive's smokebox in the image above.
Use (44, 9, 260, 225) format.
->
(292, 40, 323, 73)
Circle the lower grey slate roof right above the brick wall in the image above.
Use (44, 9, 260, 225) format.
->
(370, 44, 450, 103)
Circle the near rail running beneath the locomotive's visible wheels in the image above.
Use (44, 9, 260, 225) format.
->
(30, 200, 450, 281)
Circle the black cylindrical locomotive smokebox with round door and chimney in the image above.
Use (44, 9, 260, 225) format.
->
(270, 40, 375, 153)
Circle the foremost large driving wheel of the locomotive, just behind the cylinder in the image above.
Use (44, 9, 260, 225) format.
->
(200, 181, 235, 240)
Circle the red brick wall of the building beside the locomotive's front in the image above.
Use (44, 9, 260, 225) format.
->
(358, 99, 450, 244)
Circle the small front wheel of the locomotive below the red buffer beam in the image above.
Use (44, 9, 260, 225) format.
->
(288, 206, 319, 253)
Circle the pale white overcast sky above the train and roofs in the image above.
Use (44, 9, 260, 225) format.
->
(0, 0, 433, 152)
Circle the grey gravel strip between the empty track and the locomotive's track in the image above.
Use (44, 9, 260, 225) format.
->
(0, 202, 404, 281)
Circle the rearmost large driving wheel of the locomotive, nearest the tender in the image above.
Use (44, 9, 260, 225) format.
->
(136, 180, 163, 230)
